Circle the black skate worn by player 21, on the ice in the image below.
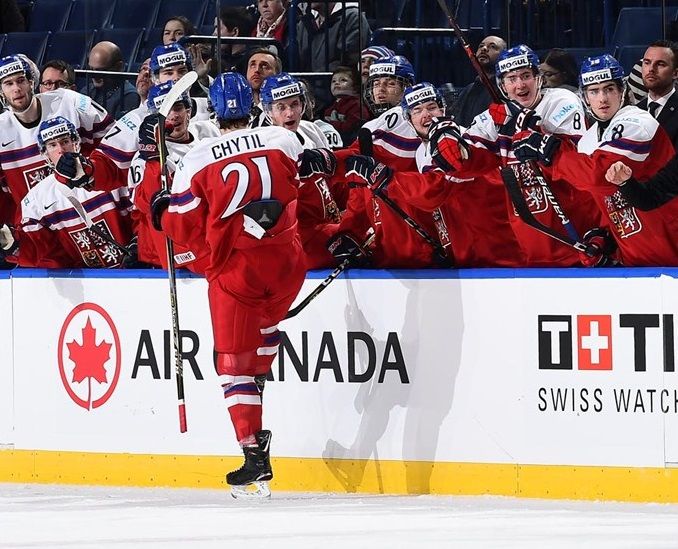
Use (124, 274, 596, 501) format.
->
(226, 430, 273, 498)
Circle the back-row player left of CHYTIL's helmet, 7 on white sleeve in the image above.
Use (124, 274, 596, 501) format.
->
(92, 42, 209, 171)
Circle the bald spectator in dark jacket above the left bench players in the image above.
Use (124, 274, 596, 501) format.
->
(81, 42, 139, 119)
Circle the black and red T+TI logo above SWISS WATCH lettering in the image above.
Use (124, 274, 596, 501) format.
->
(537, 314, 675, 372)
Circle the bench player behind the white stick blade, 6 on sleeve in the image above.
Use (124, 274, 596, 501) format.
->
(128, 80, 219, 273)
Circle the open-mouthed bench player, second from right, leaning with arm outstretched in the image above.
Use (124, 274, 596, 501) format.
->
(429, 44, 600, 267)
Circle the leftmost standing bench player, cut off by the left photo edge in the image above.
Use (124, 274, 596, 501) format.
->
(0, 55, 113, 216)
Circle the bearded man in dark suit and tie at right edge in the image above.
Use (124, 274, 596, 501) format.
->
(638, 40, 678, 149)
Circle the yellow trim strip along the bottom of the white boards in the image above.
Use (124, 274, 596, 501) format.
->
(0, 450, 678, 503)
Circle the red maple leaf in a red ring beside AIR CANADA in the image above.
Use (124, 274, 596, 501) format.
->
(58, 303, 121, 410)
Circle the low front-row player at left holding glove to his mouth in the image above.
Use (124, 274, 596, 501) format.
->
(0, 116, 132, 268)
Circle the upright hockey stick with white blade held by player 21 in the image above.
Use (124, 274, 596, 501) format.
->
(156, 71, 198, 433)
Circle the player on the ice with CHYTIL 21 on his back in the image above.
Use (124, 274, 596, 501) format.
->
(152, 73, 306, 496)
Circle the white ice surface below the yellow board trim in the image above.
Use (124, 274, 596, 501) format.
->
(0, 484, 678, 549)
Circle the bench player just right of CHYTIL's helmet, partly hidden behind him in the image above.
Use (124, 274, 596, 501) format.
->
(259, 72, 347, 269)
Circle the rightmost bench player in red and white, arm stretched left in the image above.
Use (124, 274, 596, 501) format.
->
(516, 55, 678, 266)
